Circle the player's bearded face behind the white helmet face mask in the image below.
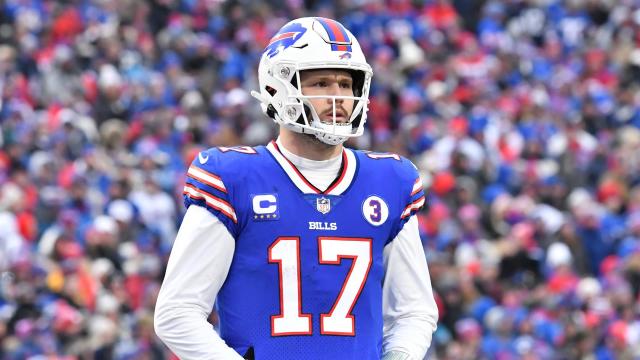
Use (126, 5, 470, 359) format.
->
(300, 69, 354, 124)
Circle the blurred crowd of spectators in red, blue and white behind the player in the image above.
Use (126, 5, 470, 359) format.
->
(0, 0, 640, 360)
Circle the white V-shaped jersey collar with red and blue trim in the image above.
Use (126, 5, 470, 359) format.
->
(267, 141, 357, 195)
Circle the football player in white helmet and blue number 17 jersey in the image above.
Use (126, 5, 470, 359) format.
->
(155, 17, 438, 360)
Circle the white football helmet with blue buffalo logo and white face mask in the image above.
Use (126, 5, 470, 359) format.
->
(251, 17, 373, 145)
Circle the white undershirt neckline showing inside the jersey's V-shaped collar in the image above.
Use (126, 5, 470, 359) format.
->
(276, 138, 342, 191)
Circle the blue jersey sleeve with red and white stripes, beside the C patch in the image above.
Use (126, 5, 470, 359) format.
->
(183, 149, 238, 237)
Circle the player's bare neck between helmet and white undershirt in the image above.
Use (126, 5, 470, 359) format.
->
(279, 129, 342, 160)
